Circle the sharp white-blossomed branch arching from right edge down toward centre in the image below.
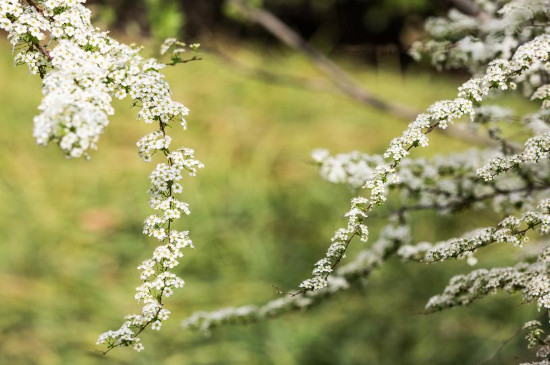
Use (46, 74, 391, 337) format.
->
(300, 35, 550, 292)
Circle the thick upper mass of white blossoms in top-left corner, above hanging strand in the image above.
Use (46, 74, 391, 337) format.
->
(0, 0, 194, 157)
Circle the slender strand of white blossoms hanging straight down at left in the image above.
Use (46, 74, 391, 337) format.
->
(98, 60, 203, 351)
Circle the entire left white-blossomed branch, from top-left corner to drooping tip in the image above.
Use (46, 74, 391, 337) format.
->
(0, 0, 202, 351)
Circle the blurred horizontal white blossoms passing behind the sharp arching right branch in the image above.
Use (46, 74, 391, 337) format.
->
(313, 149, 550, 214)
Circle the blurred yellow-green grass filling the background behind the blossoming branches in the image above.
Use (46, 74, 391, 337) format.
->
(0, 38, 537, 365)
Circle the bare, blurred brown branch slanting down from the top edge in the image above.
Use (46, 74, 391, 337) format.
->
(227, 0, 494, 145)
